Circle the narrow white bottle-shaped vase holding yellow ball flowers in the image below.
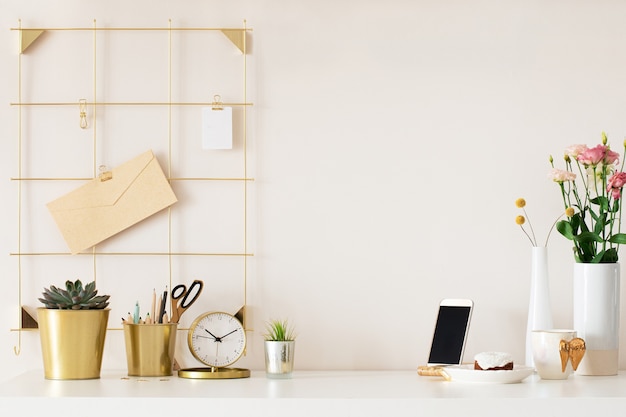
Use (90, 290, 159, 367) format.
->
(525, 246, 553, 366)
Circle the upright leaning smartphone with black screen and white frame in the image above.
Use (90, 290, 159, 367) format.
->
(428, 298, 474, 366)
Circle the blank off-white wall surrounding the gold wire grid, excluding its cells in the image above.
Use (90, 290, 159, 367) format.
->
(0, 0, 626, 378)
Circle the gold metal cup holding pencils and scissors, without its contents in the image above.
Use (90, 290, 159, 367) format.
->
(124, 323, 178, 376)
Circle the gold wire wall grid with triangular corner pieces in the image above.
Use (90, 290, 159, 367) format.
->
(10, 20, 254, 355)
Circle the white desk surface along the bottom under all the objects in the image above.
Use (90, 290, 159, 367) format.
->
(0, 370, 626, 417)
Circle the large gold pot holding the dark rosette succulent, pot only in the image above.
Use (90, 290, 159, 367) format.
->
(37, 308, 110, 379)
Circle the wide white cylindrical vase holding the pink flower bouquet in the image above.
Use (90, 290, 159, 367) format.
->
(574, 263, 620, 375)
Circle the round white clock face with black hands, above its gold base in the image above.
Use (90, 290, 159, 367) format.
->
(187, 312, 246, 368)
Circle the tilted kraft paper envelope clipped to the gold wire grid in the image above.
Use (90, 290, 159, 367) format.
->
(47, 151, 177, 254)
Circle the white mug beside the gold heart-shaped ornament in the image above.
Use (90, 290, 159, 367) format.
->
(532, 329, 576, 379)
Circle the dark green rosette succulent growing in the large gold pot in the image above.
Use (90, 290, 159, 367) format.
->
(39, 279, 110, 310)
